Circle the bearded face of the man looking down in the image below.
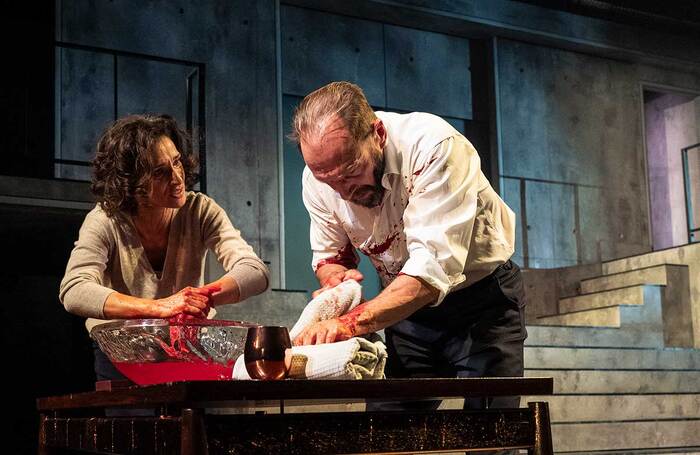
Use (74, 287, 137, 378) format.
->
(300, 118, 386, 208)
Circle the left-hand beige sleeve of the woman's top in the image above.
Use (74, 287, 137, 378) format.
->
(59, 210, 114, 319)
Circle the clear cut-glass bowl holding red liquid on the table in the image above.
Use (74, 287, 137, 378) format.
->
(90, 319, 258, 385)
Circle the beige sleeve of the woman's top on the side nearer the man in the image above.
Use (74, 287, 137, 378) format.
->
(202, 199, 270, 300)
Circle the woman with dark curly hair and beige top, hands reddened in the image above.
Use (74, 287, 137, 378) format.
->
(60, 115, 269, 380)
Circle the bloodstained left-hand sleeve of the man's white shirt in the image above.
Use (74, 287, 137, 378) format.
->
(302, 169, 360, 272)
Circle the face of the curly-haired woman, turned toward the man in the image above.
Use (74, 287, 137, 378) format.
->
(140, 136, 186, 208)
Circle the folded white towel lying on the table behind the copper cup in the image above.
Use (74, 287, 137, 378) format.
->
(233, 337, 387, 379)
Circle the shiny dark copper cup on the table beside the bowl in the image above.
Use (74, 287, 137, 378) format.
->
(243, 326, 292, 380)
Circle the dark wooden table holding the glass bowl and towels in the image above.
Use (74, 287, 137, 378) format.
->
(37, 378, 553, 455)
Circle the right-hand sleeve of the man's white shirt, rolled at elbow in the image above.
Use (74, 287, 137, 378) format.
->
(401, 135, 480, 305)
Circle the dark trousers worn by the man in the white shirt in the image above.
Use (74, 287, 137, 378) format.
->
(367, 261, 527, 410)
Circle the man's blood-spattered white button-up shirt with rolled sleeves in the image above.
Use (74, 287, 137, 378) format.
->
(302, 112, 515, 305)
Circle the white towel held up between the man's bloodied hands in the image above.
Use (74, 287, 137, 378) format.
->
(289, 280, 362, 340)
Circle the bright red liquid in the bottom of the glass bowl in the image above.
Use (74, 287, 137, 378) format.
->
(114, 360, 233, 385)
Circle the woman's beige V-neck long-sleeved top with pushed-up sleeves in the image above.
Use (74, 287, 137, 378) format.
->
(59, 192, 269, 330)
